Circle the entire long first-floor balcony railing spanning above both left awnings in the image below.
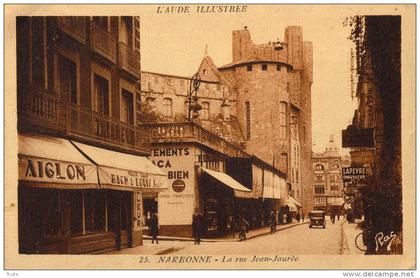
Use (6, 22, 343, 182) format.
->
(18, 89, 150, 153)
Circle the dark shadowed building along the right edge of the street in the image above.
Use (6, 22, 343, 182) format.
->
(343, 16, 402, 254)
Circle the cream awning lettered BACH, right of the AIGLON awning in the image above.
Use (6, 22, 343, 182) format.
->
(72, 142, 168, 191)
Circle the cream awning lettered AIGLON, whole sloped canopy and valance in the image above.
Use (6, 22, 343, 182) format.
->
(18, 134, 98, 189)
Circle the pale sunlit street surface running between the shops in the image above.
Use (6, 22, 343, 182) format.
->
(107, 219, 348, 255)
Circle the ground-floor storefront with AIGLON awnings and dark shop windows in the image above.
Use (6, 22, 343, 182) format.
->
(18, 135, 167, 254)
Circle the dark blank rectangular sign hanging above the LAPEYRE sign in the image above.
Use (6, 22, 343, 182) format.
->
(342, 126, 374, 148)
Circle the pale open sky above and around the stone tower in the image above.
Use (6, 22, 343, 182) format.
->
(141, 5, 357, 154)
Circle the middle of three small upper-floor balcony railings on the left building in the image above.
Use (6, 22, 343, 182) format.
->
(90, 22, 117, 63)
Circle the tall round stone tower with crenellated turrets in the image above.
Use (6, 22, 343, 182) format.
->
(219, 26, 313, 212)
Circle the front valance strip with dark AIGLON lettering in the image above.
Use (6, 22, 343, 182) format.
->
(19, 157, 98, 184)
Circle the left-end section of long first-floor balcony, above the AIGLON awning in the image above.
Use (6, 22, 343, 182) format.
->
(18, 87, 65, 129)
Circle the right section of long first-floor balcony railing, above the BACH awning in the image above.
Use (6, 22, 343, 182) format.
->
(67, 105, 150, 151)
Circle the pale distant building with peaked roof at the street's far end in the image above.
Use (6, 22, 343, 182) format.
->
(312, 136, 349, 214)
